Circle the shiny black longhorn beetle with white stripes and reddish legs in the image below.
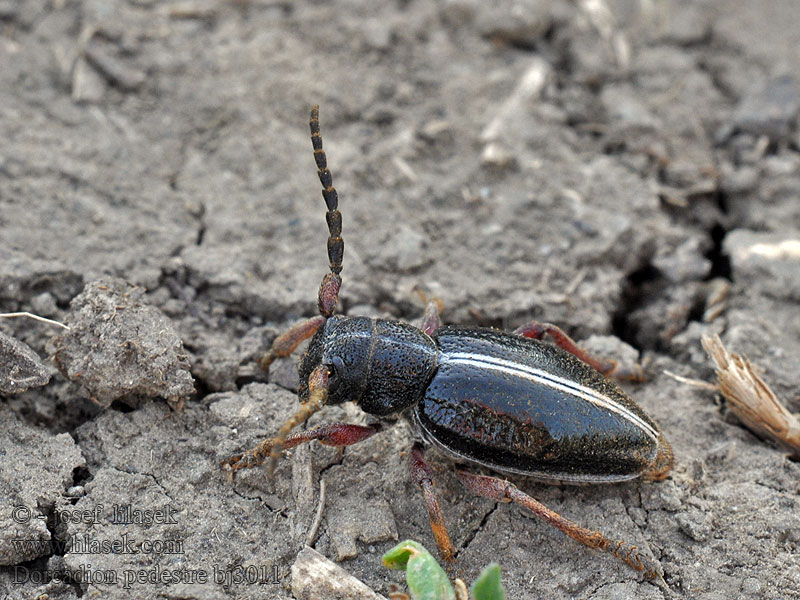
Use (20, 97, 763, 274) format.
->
(222, 105, 673, 577)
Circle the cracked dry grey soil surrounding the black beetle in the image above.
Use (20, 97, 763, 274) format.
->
(0, 0, 800, 600)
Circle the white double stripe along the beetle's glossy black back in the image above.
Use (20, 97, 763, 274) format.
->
(442, 352, 658, 443)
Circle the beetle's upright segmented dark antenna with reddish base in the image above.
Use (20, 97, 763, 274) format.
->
(309, 104, 344, 318)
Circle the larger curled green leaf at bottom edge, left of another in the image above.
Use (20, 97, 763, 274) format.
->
(383, 540, 456, 600)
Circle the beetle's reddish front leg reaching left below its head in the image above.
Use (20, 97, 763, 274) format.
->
(222, 423, 382, 471)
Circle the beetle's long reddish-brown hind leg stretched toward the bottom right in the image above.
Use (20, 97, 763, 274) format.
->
(456, 469, 661, 579)
